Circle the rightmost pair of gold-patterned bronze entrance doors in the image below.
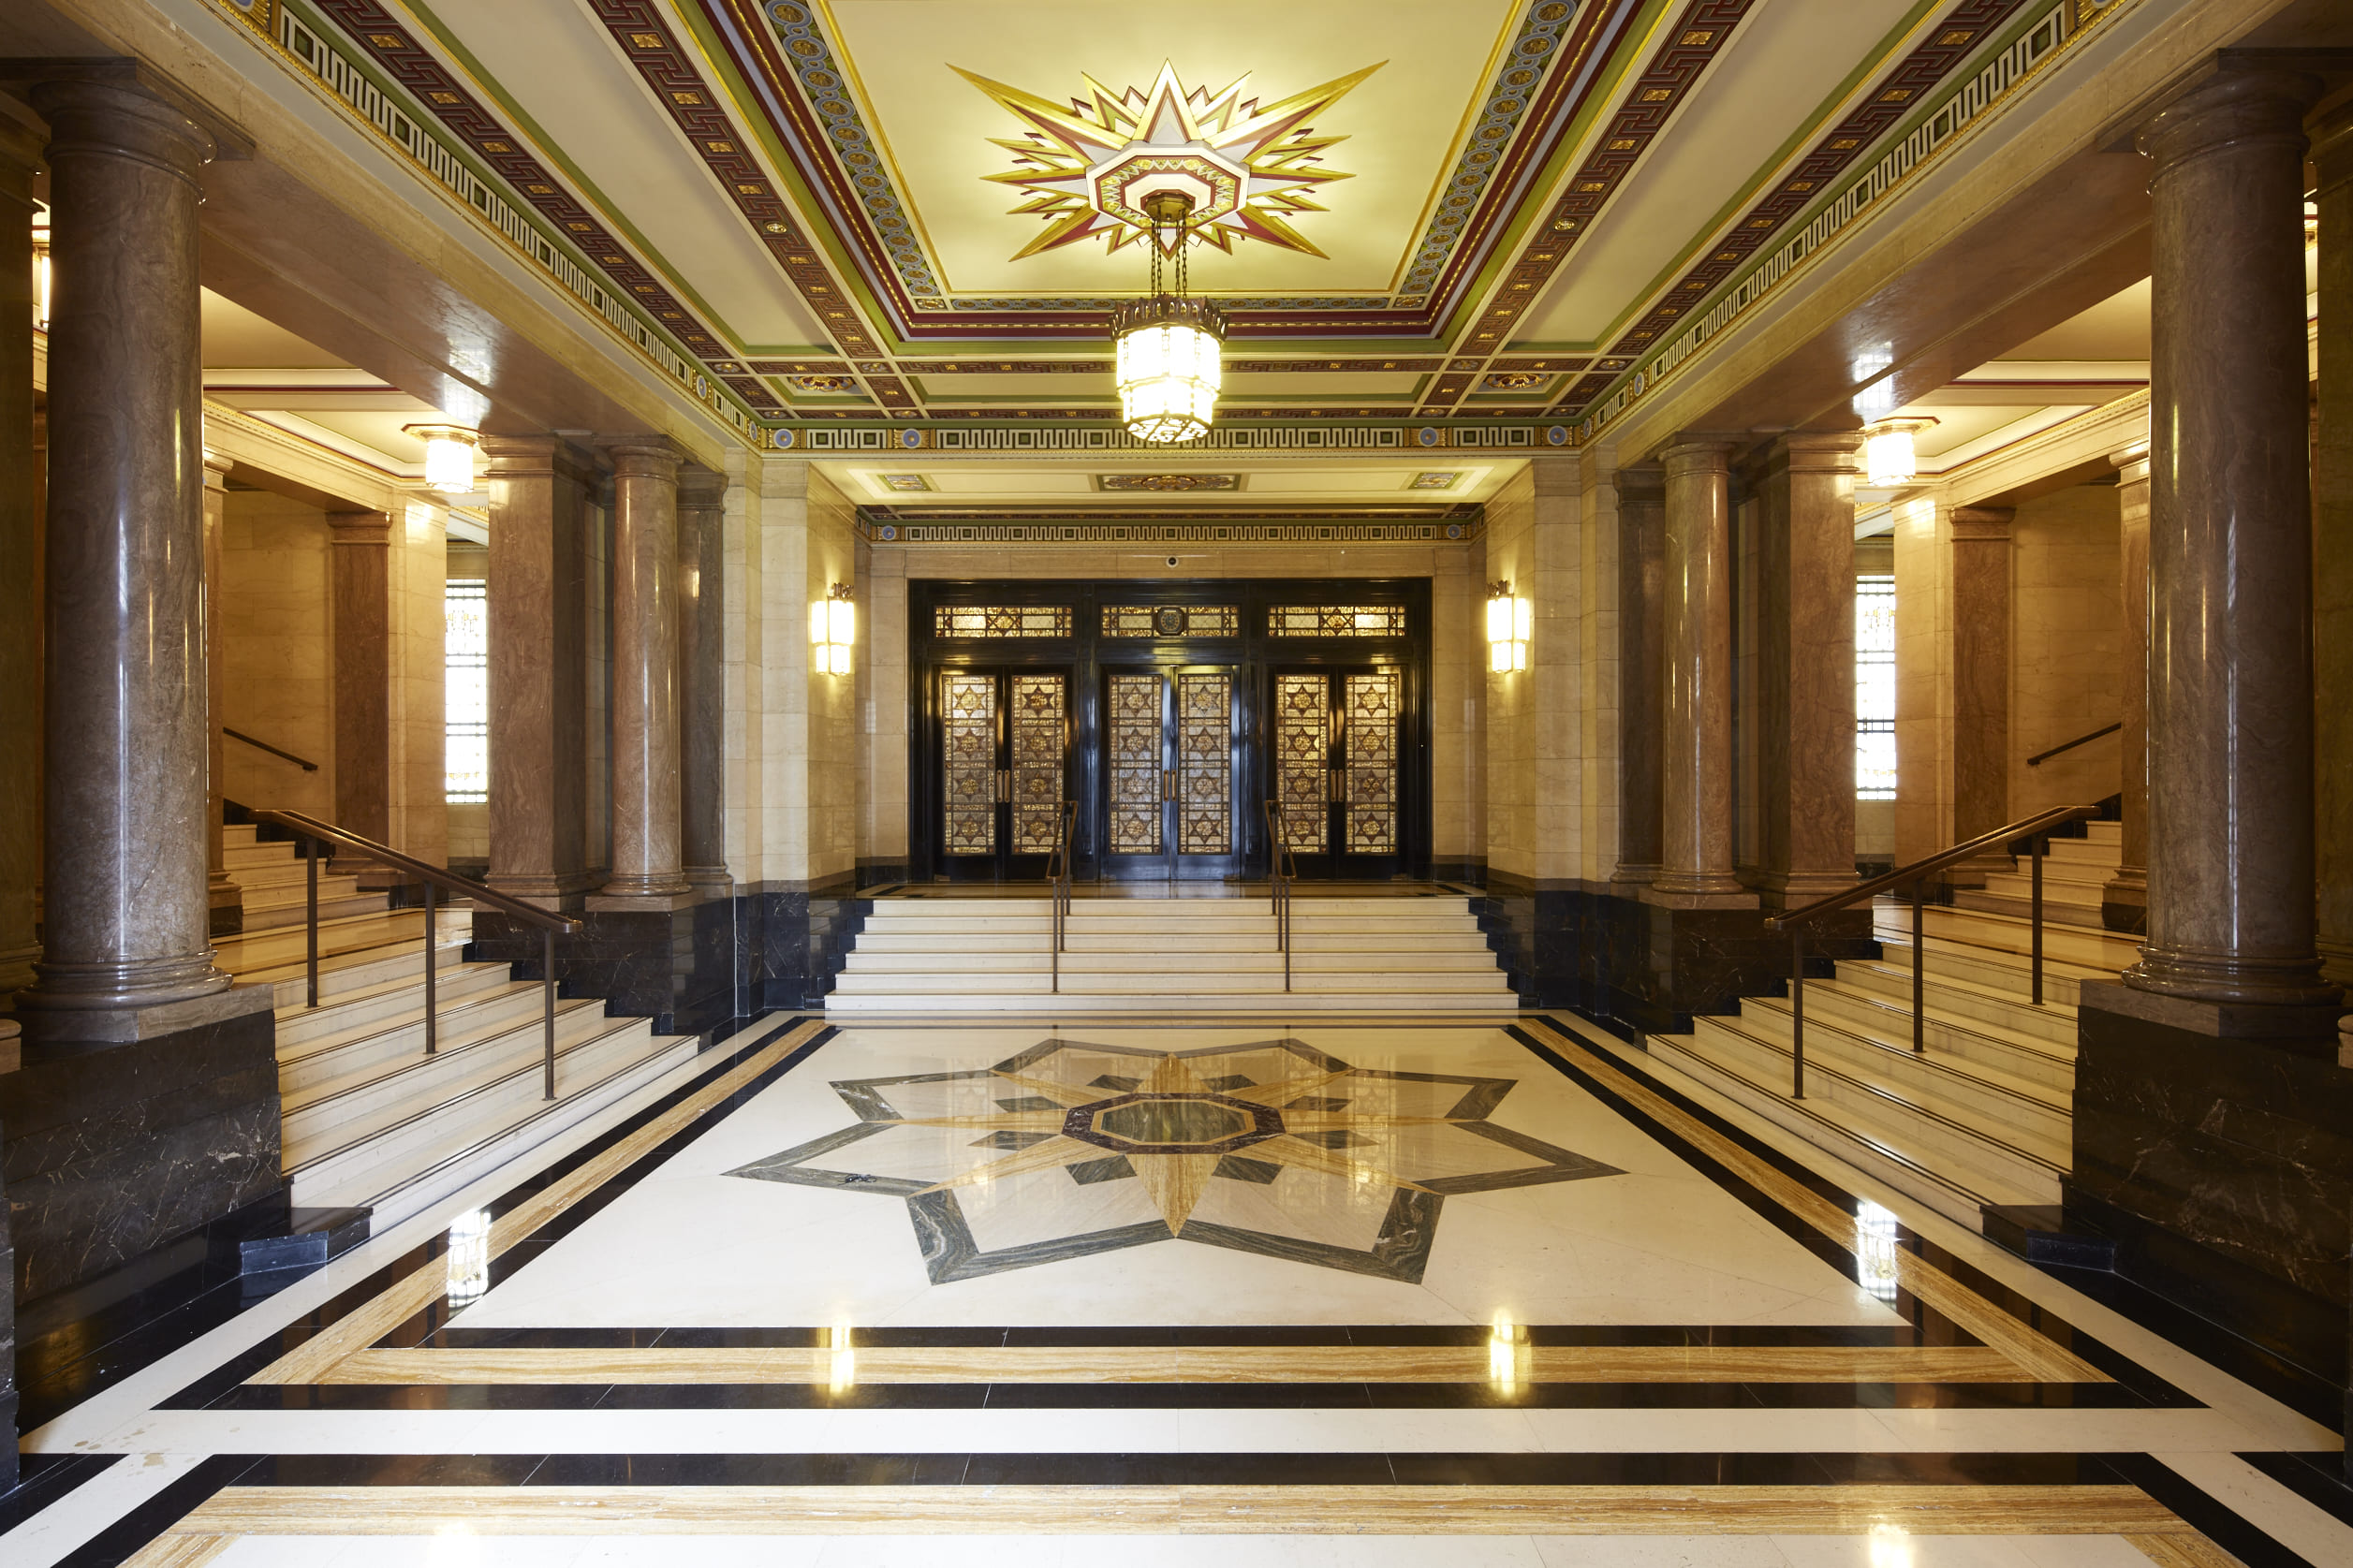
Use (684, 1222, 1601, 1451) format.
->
(1266, 666, 1407, 879)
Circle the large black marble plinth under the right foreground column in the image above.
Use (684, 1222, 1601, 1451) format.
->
(2066, 985, 2353, 1387)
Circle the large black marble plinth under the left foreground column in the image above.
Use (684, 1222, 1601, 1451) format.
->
(0, 1011, 280, 1302)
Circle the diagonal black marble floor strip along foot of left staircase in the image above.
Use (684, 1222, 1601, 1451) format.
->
(155, 1011, 838, 1411)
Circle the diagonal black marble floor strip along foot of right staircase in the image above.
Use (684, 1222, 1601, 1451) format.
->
(1504, 1018, 2205, 1411)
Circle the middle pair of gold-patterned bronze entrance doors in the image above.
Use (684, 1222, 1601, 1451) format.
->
(1099, 663, 1244, 882)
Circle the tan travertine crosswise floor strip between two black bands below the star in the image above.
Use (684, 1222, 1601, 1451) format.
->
(336, 1344, 2028, 1385)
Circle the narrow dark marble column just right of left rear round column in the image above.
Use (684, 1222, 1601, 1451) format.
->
(678, 463, 729, 898)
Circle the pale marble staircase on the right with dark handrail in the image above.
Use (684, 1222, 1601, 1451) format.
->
(1647, 846, 2139, 1229)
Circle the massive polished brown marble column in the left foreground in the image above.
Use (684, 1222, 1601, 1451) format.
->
(17, 80, 246, 1044)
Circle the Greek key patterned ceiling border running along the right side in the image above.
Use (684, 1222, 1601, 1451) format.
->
(1555, 0, 2139, 442)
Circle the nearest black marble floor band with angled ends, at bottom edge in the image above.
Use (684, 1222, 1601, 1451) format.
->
(46, 1453, 2316, 1568)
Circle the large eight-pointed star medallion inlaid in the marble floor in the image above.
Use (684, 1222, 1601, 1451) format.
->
(729, 1039, 1624, 1283)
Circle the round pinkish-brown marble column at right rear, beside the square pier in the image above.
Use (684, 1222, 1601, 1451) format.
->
(1642, 435, 1757, 910)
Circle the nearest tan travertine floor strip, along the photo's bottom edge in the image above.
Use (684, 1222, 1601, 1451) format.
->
(161, 1486, 2205, 1542)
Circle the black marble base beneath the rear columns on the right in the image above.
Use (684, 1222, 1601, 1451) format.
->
(1473, 872, 1877, 1036)
